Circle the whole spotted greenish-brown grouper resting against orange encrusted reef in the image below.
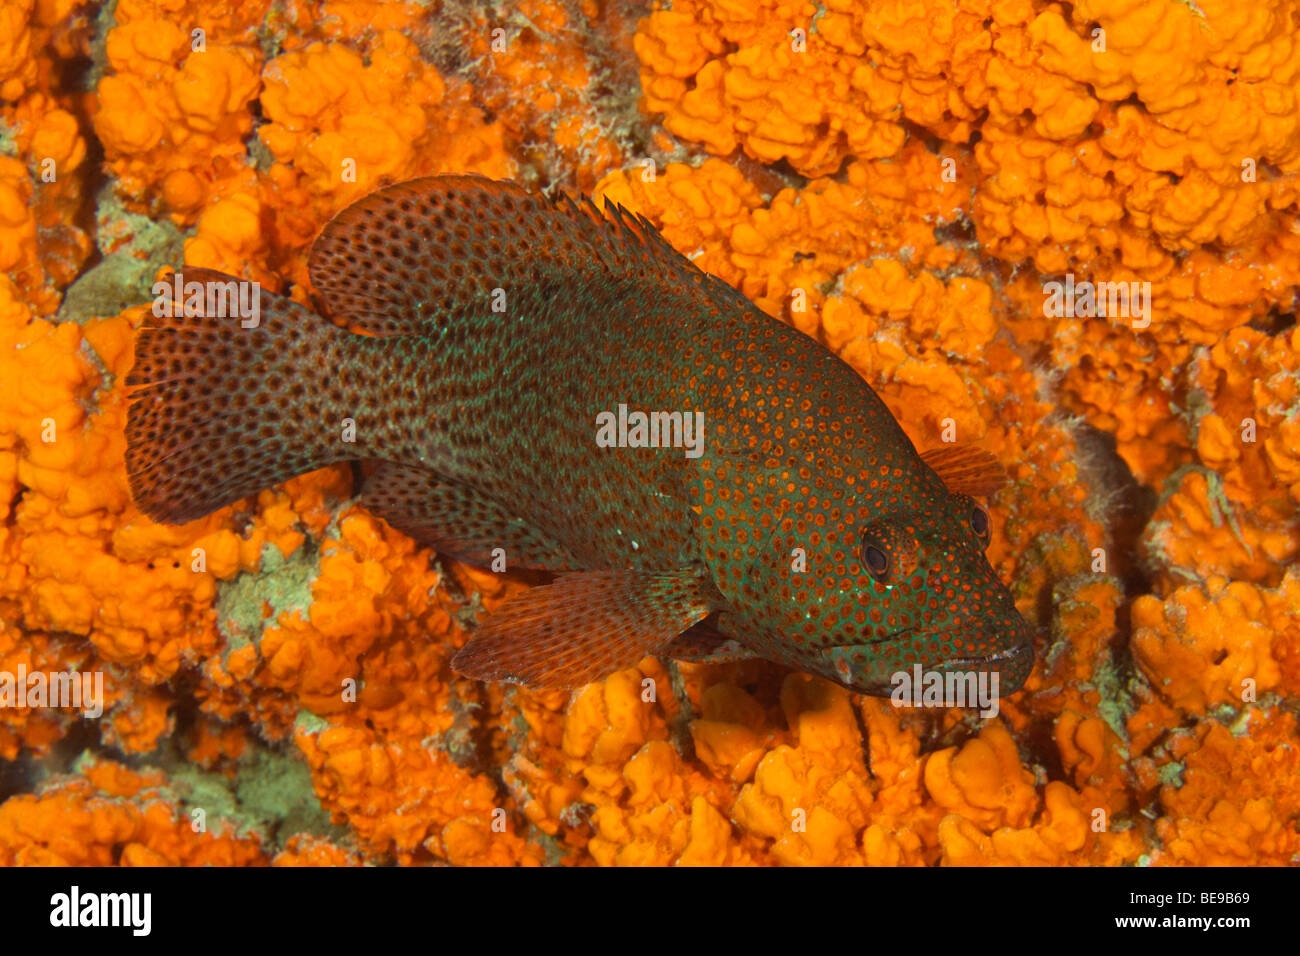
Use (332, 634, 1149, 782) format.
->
(126, 174, 1034, 696)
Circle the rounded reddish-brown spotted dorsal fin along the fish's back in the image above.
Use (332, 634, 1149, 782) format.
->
(308, 176, 748, 336)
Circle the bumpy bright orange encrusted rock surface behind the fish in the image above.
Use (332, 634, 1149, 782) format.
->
(0, 0, 1300, 865)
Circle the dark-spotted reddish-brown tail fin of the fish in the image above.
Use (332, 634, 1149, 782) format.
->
(126, 268, 364, 524)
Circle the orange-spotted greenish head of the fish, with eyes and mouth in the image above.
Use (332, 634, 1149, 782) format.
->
(755, 489, 1034, 696)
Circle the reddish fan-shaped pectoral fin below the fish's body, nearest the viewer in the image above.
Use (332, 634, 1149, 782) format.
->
(451, 568, 720, 688)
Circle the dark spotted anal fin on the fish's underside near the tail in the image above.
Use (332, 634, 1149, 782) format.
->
(361, 462, 577, 571)
